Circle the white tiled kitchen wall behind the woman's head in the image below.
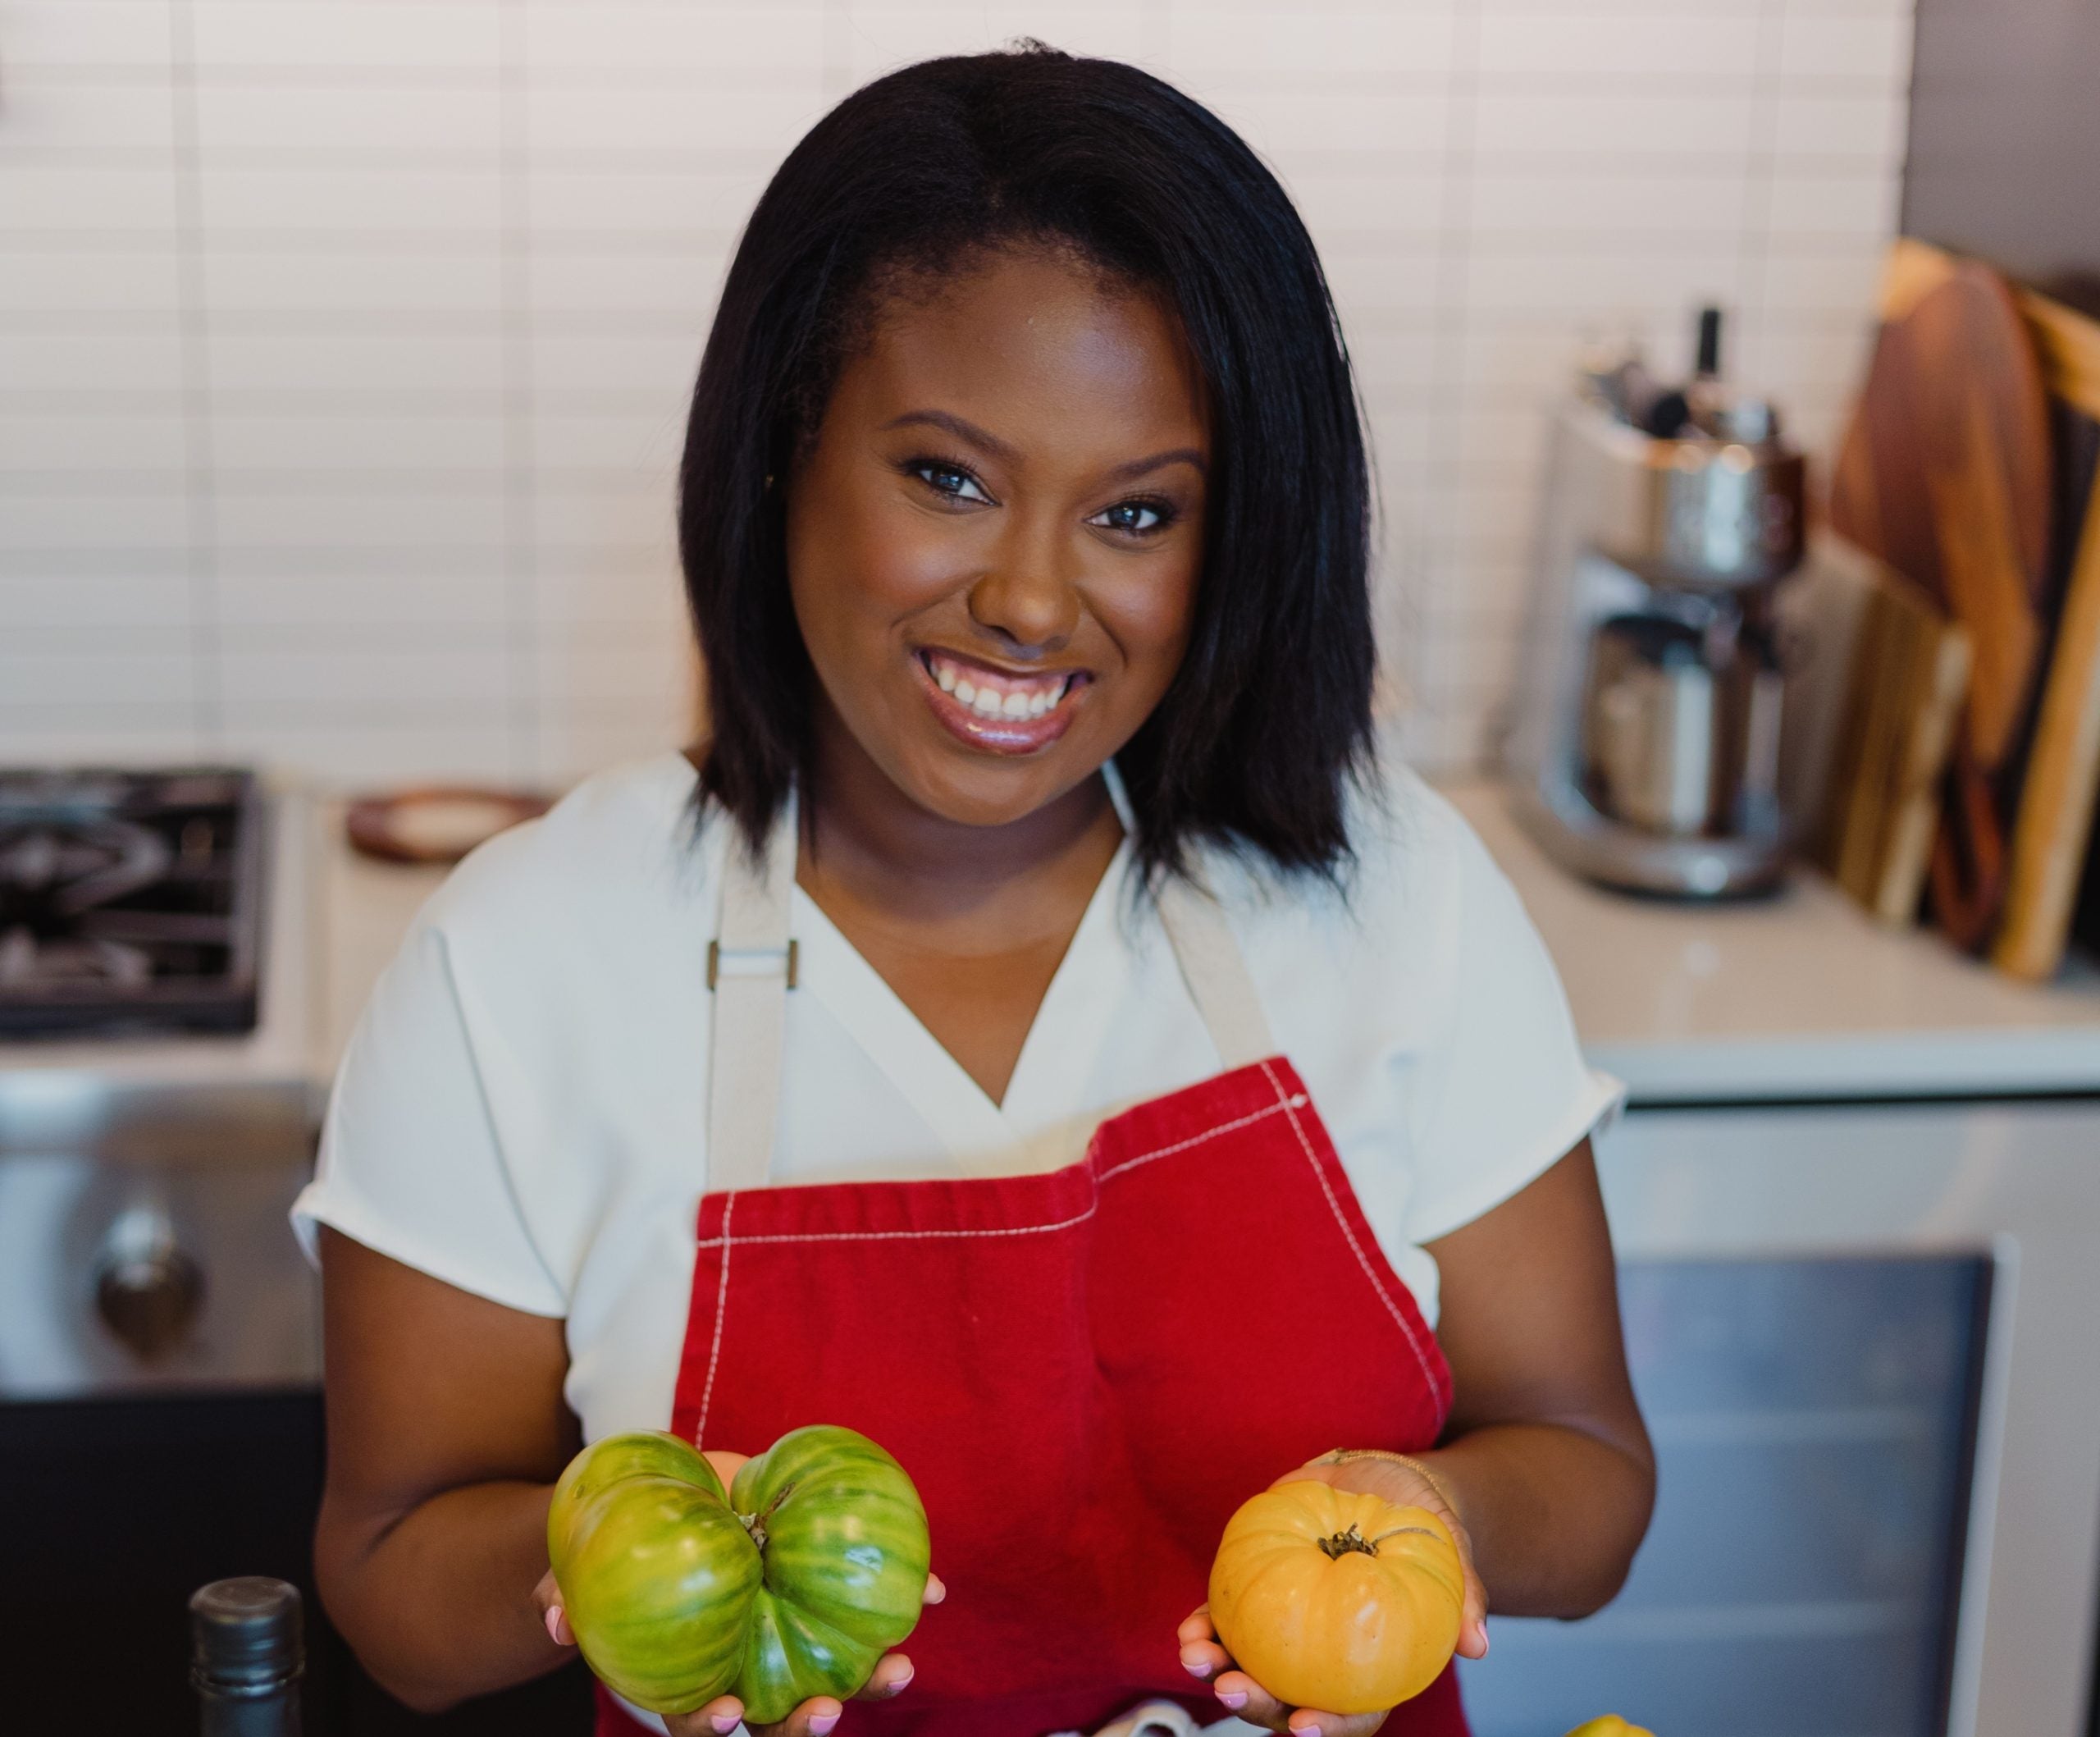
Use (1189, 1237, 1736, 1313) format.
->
(0, 0, 1911, 779)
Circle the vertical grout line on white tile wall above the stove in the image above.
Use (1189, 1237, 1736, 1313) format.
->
(168, 0, 226, 758)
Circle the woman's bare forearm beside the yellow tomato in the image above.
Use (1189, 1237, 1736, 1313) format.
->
(1418, 1424, 1655, 1617)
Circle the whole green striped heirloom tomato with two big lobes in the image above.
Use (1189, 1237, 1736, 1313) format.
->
(546, 1424, 930, 1725)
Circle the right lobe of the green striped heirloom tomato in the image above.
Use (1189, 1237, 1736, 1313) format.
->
(728, 1424, 930, 1725)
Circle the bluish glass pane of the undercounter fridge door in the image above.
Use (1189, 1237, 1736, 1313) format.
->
(1466, 1250, 1982, 1737)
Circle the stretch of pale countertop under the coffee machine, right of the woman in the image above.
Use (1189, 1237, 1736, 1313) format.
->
(1445, 784, 2100, 1103)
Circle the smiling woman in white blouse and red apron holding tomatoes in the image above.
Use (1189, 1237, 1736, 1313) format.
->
(300, 46, 1653, 1737)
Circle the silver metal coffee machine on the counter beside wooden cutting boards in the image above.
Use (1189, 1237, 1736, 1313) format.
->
(1506, 309, 1804, 899)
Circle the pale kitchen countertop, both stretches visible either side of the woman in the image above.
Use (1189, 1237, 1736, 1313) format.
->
(0, 781, 2100, 1122)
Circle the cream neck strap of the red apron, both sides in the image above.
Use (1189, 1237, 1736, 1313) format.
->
(708, 785, 1275, 1193)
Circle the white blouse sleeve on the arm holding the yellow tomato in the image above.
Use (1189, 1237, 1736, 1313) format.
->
(1407, 813, 1625, 1246)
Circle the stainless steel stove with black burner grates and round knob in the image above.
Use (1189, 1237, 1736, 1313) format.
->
(0, 766, 588, 1737)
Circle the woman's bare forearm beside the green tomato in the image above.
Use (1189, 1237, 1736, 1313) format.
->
(315, 1483, 573, 1712)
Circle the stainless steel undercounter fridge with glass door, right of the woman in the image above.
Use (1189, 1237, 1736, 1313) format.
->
(1466, 1092, 2100, 1737)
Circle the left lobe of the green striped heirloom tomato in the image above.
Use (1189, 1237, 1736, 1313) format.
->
(546, 1433, 760, 1714)
